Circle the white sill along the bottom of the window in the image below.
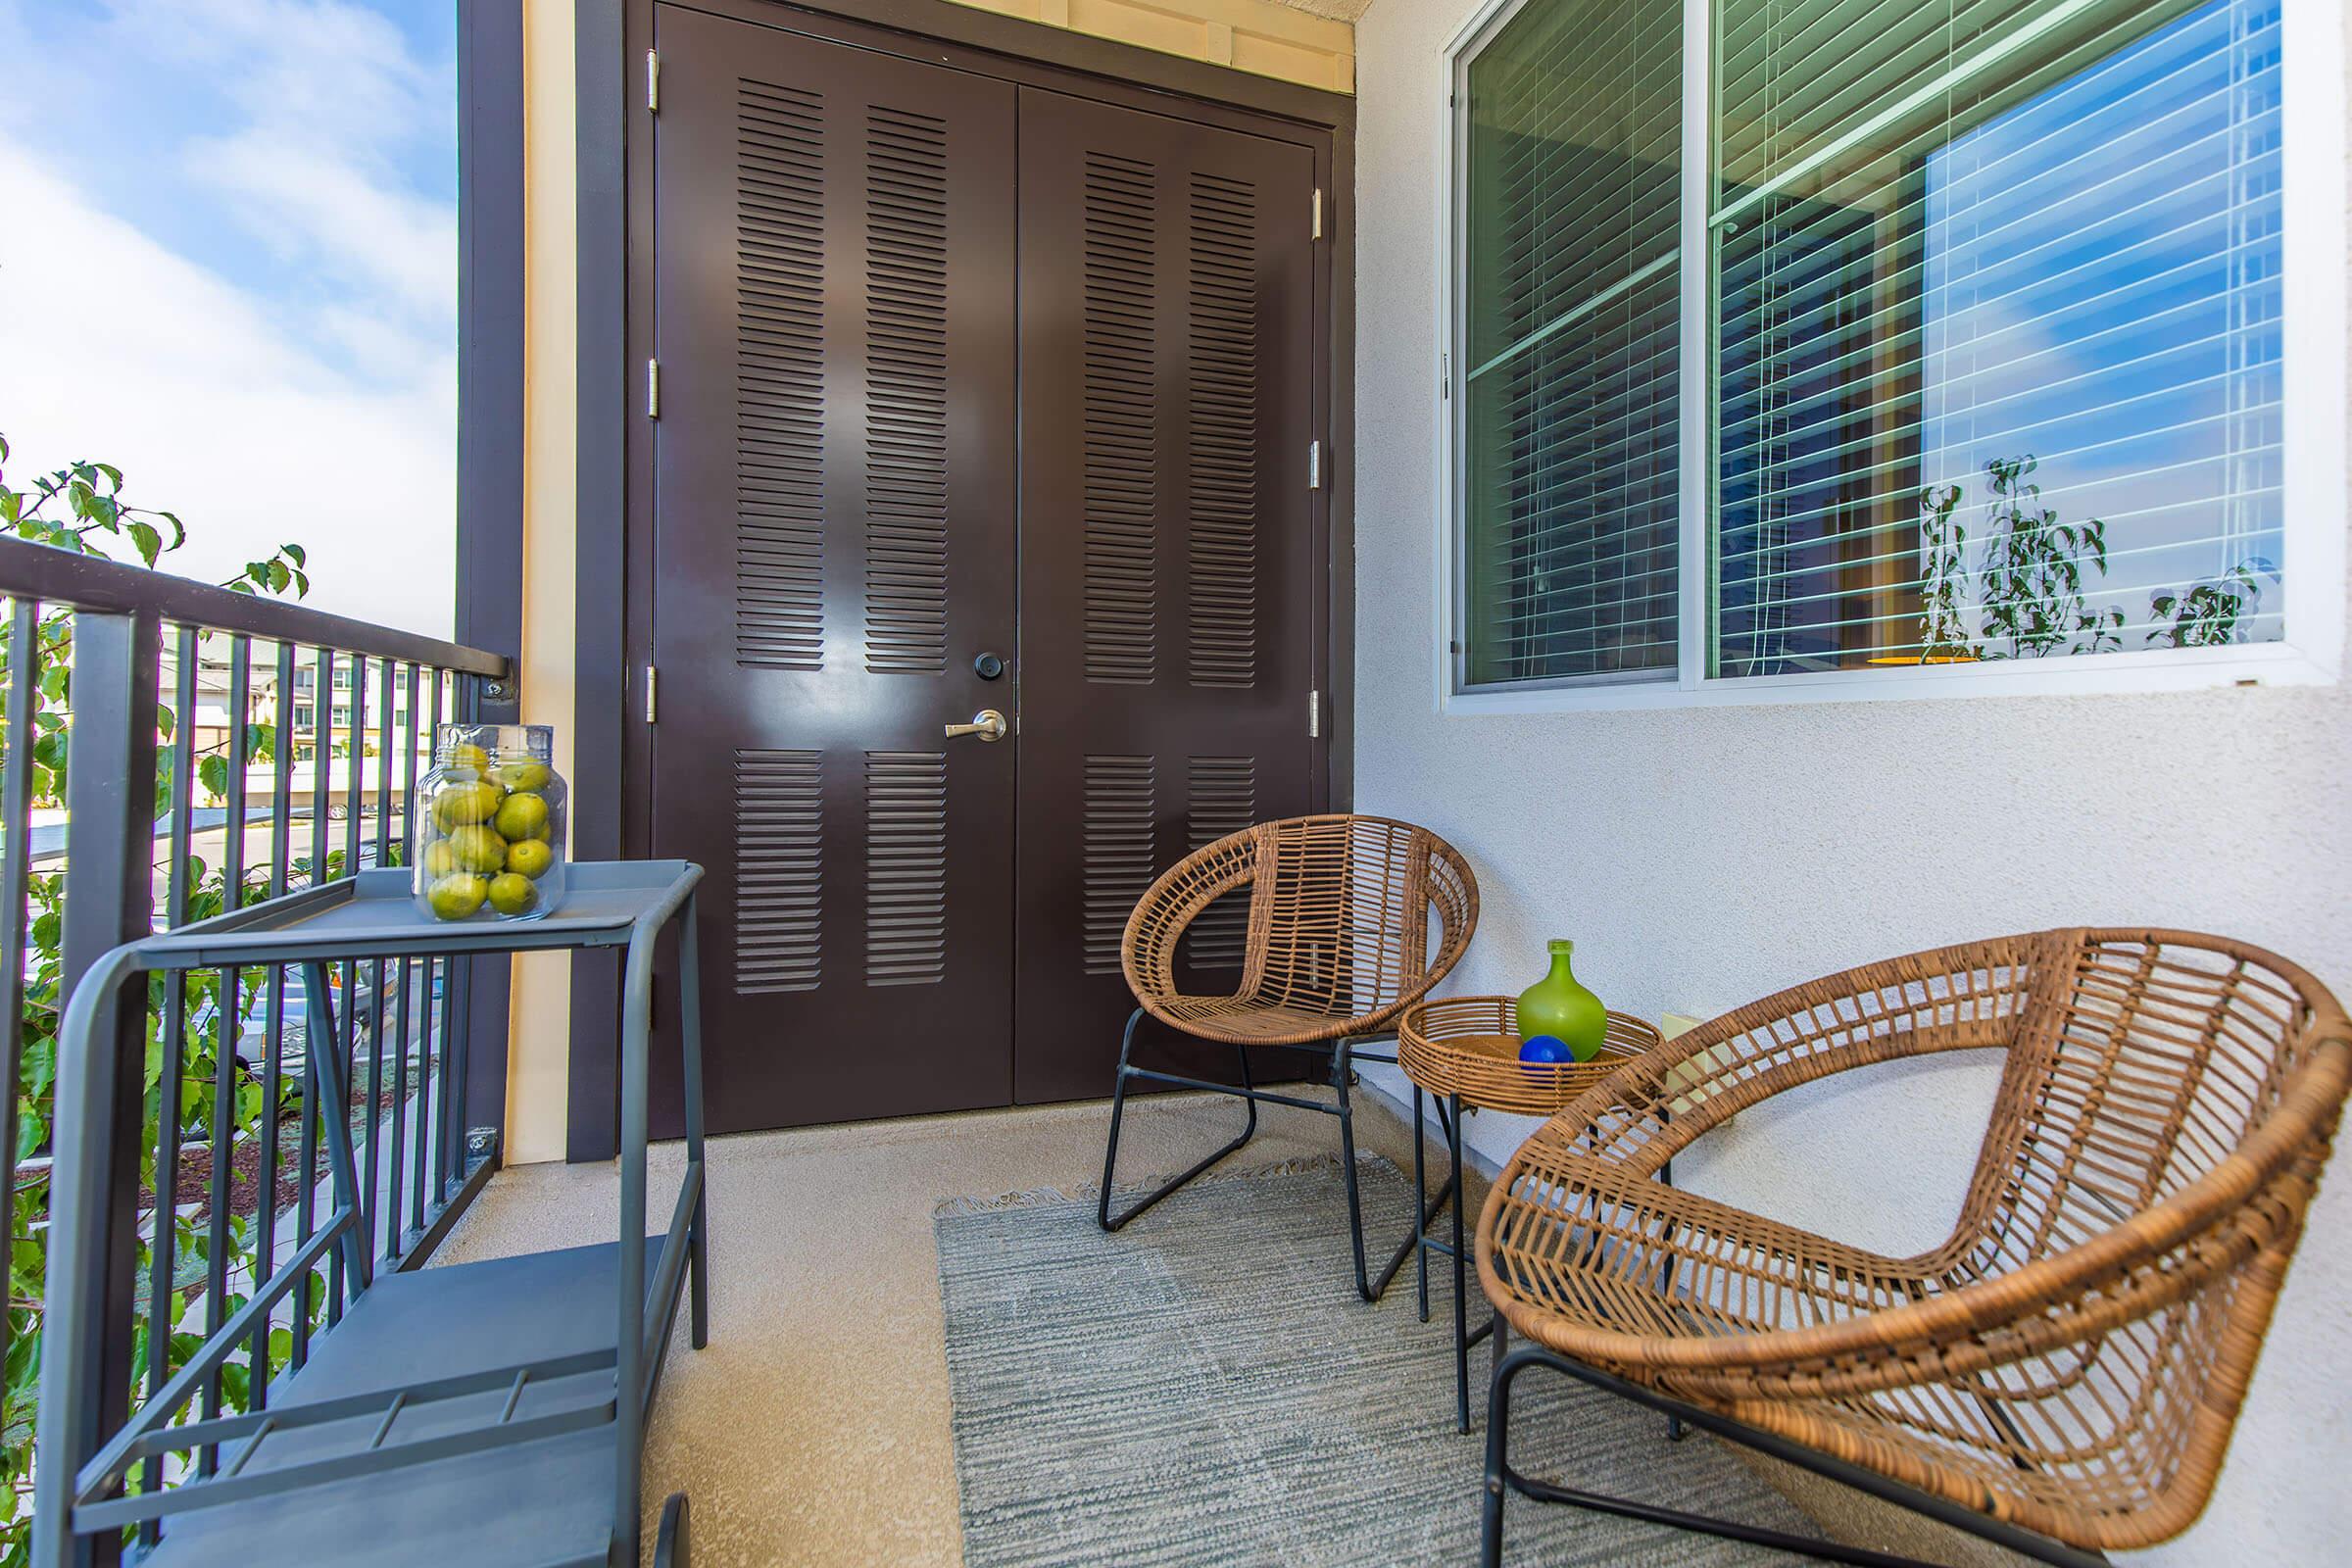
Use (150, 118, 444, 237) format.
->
(1437, 642, 2335, 717)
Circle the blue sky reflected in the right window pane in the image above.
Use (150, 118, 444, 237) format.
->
(1922, 0, 2283, 625)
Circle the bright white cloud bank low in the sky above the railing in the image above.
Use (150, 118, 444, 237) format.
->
(0, 139, 457, 635)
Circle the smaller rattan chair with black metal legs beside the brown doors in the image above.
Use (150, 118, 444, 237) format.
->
(1096, 815, 1477, 1300)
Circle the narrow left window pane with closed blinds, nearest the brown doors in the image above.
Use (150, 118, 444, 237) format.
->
(1460, 0, 1682, 684)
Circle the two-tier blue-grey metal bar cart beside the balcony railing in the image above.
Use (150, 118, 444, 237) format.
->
(33, 860, 708, 1568)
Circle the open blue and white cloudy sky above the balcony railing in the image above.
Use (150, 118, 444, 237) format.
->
(0, 0, 457, 632)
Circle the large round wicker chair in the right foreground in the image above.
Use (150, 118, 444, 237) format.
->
(1477, 931, 2352, 1563)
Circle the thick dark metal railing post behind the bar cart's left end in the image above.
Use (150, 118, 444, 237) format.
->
(40, 612, 162, 1563)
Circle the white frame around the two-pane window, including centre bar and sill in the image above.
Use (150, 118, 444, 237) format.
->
(1433, 0, 2352, 712)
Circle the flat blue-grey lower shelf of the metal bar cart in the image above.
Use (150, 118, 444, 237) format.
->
(141, 1237, 665, 1568)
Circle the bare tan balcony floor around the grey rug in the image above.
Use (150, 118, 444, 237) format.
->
(445, 1091, 1430, 1568)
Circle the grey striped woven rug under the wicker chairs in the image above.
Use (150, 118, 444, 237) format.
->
(936, 1156, 1809, 1568)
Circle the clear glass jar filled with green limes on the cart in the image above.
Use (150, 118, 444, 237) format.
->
(412, 724, 564, 921)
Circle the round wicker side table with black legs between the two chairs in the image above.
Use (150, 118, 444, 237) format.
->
(1397, 997, 1672, 1432)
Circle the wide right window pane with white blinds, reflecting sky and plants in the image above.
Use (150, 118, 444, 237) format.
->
(1707, 0, 2286, 677)
